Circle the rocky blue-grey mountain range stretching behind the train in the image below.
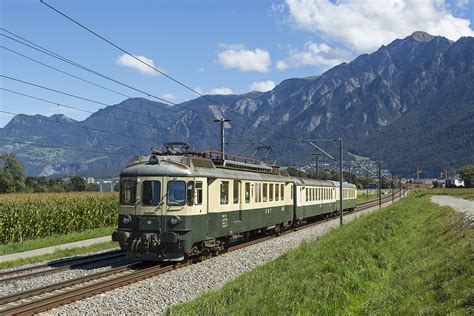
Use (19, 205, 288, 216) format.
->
(0, 32, 474, 176)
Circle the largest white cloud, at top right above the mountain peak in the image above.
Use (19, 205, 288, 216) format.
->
(286, 0, 474, 52)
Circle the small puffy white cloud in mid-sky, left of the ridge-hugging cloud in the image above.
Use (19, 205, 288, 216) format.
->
(217, 48, 272, 72)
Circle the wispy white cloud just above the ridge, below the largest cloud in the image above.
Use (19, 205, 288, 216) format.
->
(276, 41, 352, 71)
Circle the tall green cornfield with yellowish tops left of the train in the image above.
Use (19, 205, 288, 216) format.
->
(0, 192, 118, 244)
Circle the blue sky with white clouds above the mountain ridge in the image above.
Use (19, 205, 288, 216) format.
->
(0, 0, 474, 127)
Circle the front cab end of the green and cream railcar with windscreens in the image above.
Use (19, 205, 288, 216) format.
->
(112, 149, 205, 261)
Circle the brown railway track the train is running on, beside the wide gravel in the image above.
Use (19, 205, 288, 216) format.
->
(0, 192, 401, 315)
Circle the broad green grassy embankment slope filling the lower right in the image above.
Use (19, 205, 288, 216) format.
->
(168, 194, 474, 315)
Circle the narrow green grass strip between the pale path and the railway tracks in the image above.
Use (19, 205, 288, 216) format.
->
(0, 241, 117, 269)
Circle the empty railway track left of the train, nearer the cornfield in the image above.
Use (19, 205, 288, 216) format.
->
(0, 250, 125, 283)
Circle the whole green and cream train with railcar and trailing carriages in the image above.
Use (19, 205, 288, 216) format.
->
(112, 142, 357, 261)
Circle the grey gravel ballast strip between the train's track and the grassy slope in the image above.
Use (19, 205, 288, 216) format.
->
(45, 203, 396, 315)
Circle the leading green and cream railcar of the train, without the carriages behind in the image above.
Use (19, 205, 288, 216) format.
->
(112, 155, 293, 260)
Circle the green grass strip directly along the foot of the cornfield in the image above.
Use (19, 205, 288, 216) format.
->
(0, 227, 115, 256)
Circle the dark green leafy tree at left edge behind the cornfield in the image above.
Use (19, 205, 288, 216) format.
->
(0, 153, 25, 193)
